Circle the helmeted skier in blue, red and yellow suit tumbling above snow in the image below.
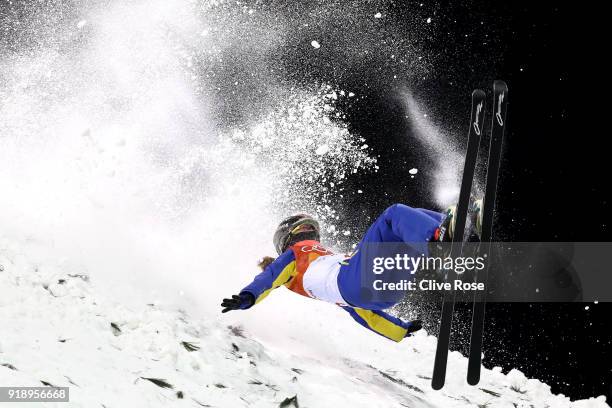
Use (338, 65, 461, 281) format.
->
(221, 204, 480, 342)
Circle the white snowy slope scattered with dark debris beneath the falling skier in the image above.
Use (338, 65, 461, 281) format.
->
(0, 240, 609, 408)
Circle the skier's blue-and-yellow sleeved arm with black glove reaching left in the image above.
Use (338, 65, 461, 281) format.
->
(221, 250, 295, 313)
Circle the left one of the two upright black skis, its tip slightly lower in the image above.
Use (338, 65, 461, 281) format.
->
(431, 89, 486, 390)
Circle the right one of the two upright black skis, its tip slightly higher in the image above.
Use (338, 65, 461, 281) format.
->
(467, 81, 508, 385)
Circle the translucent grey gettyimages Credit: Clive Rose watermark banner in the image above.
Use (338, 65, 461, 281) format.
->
(358, 242, 612, 304)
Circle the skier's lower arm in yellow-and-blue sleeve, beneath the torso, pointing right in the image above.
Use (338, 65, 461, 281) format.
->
(342, 306, 421, 342)
